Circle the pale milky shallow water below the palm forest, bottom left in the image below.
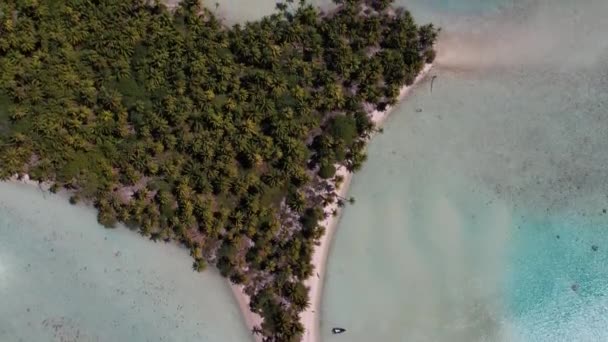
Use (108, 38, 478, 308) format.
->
(0, 182, 250, 342)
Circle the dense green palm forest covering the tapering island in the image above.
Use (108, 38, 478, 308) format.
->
(0, 0, 437, 341)
